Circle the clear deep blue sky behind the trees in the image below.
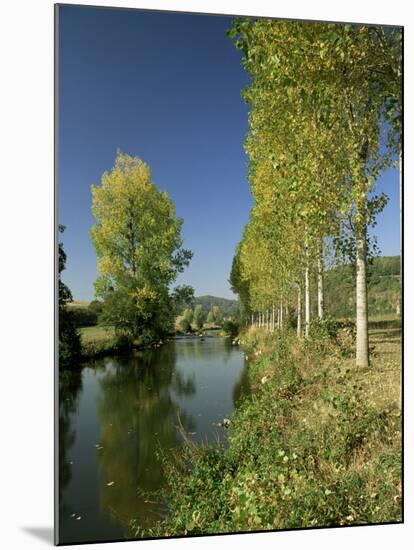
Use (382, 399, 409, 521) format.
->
(58, 6, 400, 300)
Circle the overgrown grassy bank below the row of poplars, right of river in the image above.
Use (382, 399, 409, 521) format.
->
(133, 322, 401, 536)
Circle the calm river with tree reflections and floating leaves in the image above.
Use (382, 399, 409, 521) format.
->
(59, 338, 249, 543)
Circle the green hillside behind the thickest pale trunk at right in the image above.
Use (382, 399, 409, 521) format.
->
(325, 256, 401, 317)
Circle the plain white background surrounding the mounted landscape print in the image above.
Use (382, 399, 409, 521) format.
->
(0, 0, 414, 550)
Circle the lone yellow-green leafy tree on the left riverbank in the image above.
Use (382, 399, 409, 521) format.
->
(91, 151, 192, 341)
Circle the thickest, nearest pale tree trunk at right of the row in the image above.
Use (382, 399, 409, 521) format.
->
(356, 225, 369, 367)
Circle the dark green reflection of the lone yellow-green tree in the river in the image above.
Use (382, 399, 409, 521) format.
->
(97, 344, 195, 526)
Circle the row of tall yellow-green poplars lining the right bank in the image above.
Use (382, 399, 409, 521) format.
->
(228, 19, 402, 367)
